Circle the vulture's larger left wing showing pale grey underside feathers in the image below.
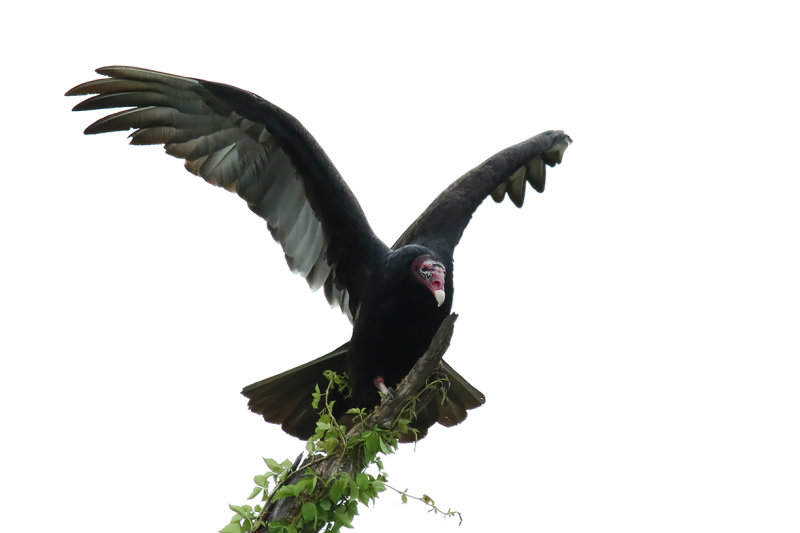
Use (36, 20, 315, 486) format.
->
(67, 67, 386, 321)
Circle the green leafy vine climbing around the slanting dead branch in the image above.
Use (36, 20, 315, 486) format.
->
(220, 371, 461, 533)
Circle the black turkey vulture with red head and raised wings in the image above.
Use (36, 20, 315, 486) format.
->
(66, 66, 571, 439)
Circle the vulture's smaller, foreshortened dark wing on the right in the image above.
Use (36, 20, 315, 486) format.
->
(393, 131, 572, 252)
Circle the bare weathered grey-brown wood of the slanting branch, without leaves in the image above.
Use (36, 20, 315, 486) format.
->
(257, 314, 457, 533)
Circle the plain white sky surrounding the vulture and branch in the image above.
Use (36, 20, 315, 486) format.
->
(0, 0, 800, 533)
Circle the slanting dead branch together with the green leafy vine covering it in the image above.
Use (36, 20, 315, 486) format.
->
(220, 315, 462, 533)
